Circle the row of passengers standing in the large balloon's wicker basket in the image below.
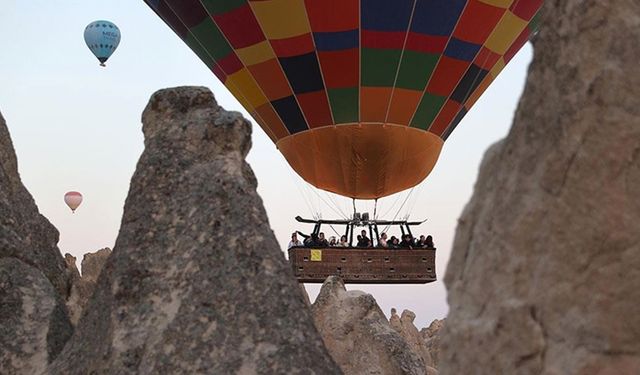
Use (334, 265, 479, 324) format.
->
(288, 230, 435, 249)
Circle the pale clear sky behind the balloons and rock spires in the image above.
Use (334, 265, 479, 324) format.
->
(0, 0, 532, 328)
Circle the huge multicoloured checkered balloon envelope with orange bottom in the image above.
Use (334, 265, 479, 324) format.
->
(145, 0, 543, 199)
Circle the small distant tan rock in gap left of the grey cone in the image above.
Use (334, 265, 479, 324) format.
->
(64, 247, 111, 324)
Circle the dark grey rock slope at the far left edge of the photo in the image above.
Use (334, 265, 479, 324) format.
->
(0, 115, 73, 374)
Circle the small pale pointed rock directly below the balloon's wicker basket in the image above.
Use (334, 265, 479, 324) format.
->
(311, 276, 429, 375)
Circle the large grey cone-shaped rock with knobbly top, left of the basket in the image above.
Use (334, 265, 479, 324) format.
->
(50, 87, 340, 374)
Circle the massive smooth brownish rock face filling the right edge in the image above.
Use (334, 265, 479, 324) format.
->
(440, 0, 640, 374)
